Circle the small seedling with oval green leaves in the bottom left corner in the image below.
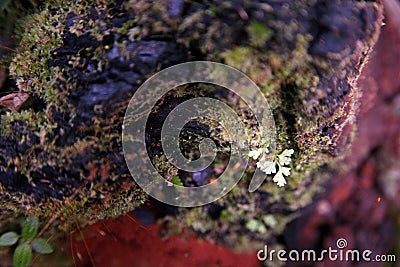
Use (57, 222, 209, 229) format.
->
(0, 217, 53, 267)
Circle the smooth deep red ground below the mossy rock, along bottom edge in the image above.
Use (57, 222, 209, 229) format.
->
(67, 215, 258, 267)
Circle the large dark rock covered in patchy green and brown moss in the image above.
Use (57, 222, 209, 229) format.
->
(0, 0, 381, 253)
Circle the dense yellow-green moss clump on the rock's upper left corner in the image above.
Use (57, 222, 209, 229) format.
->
(10, 4, 64, 103)
